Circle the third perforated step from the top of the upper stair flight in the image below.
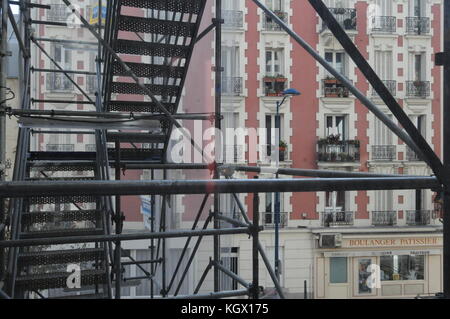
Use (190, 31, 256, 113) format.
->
(114, 39, 190, 58)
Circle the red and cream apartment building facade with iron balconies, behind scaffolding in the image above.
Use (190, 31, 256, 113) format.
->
(32, 0, 443, 298)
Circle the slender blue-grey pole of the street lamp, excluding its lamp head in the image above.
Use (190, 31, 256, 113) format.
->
(274, 101, 281, 281)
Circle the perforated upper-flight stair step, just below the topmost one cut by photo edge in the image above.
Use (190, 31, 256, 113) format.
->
(118, 15, 196, 38)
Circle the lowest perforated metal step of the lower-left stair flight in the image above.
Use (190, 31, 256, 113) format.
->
(16, 269, 106, 291)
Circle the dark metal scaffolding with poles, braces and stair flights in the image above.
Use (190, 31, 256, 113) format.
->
(0, 0, 450, 299)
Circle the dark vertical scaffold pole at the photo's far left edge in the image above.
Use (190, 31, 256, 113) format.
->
(0, 0, 8, 279)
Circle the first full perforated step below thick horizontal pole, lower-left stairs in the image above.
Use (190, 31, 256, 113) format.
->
(22, 210, 101, 226)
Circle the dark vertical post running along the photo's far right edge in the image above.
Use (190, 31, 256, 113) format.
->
(443, 0, 450, 299)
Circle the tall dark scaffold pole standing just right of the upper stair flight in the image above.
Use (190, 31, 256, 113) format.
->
(213, 0, 223, 292)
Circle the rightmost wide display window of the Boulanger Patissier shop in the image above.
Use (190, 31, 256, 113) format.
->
(380, 255, 425, 281)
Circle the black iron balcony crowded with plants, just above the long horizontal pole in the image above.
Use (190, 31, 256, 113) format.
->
(317, 136, 360, 162)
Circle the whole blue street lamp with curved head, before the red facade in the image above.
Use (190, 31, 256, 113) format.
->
(275, 88, 301, 282)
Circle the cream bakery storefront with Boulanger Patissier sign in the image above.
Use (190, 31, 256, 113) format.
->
(314, 232, 443, 299)
